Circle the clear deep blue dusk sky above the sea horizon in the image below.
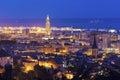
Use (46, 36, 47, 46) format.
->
(0, 0, 120, 18)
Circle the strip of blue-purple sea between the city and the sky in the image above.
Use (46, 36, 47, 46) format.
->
(0, 18, 120, 30)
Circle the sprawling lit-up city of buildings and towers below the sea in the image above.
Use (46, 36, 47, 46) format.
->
(0, 10, 120, 80)
